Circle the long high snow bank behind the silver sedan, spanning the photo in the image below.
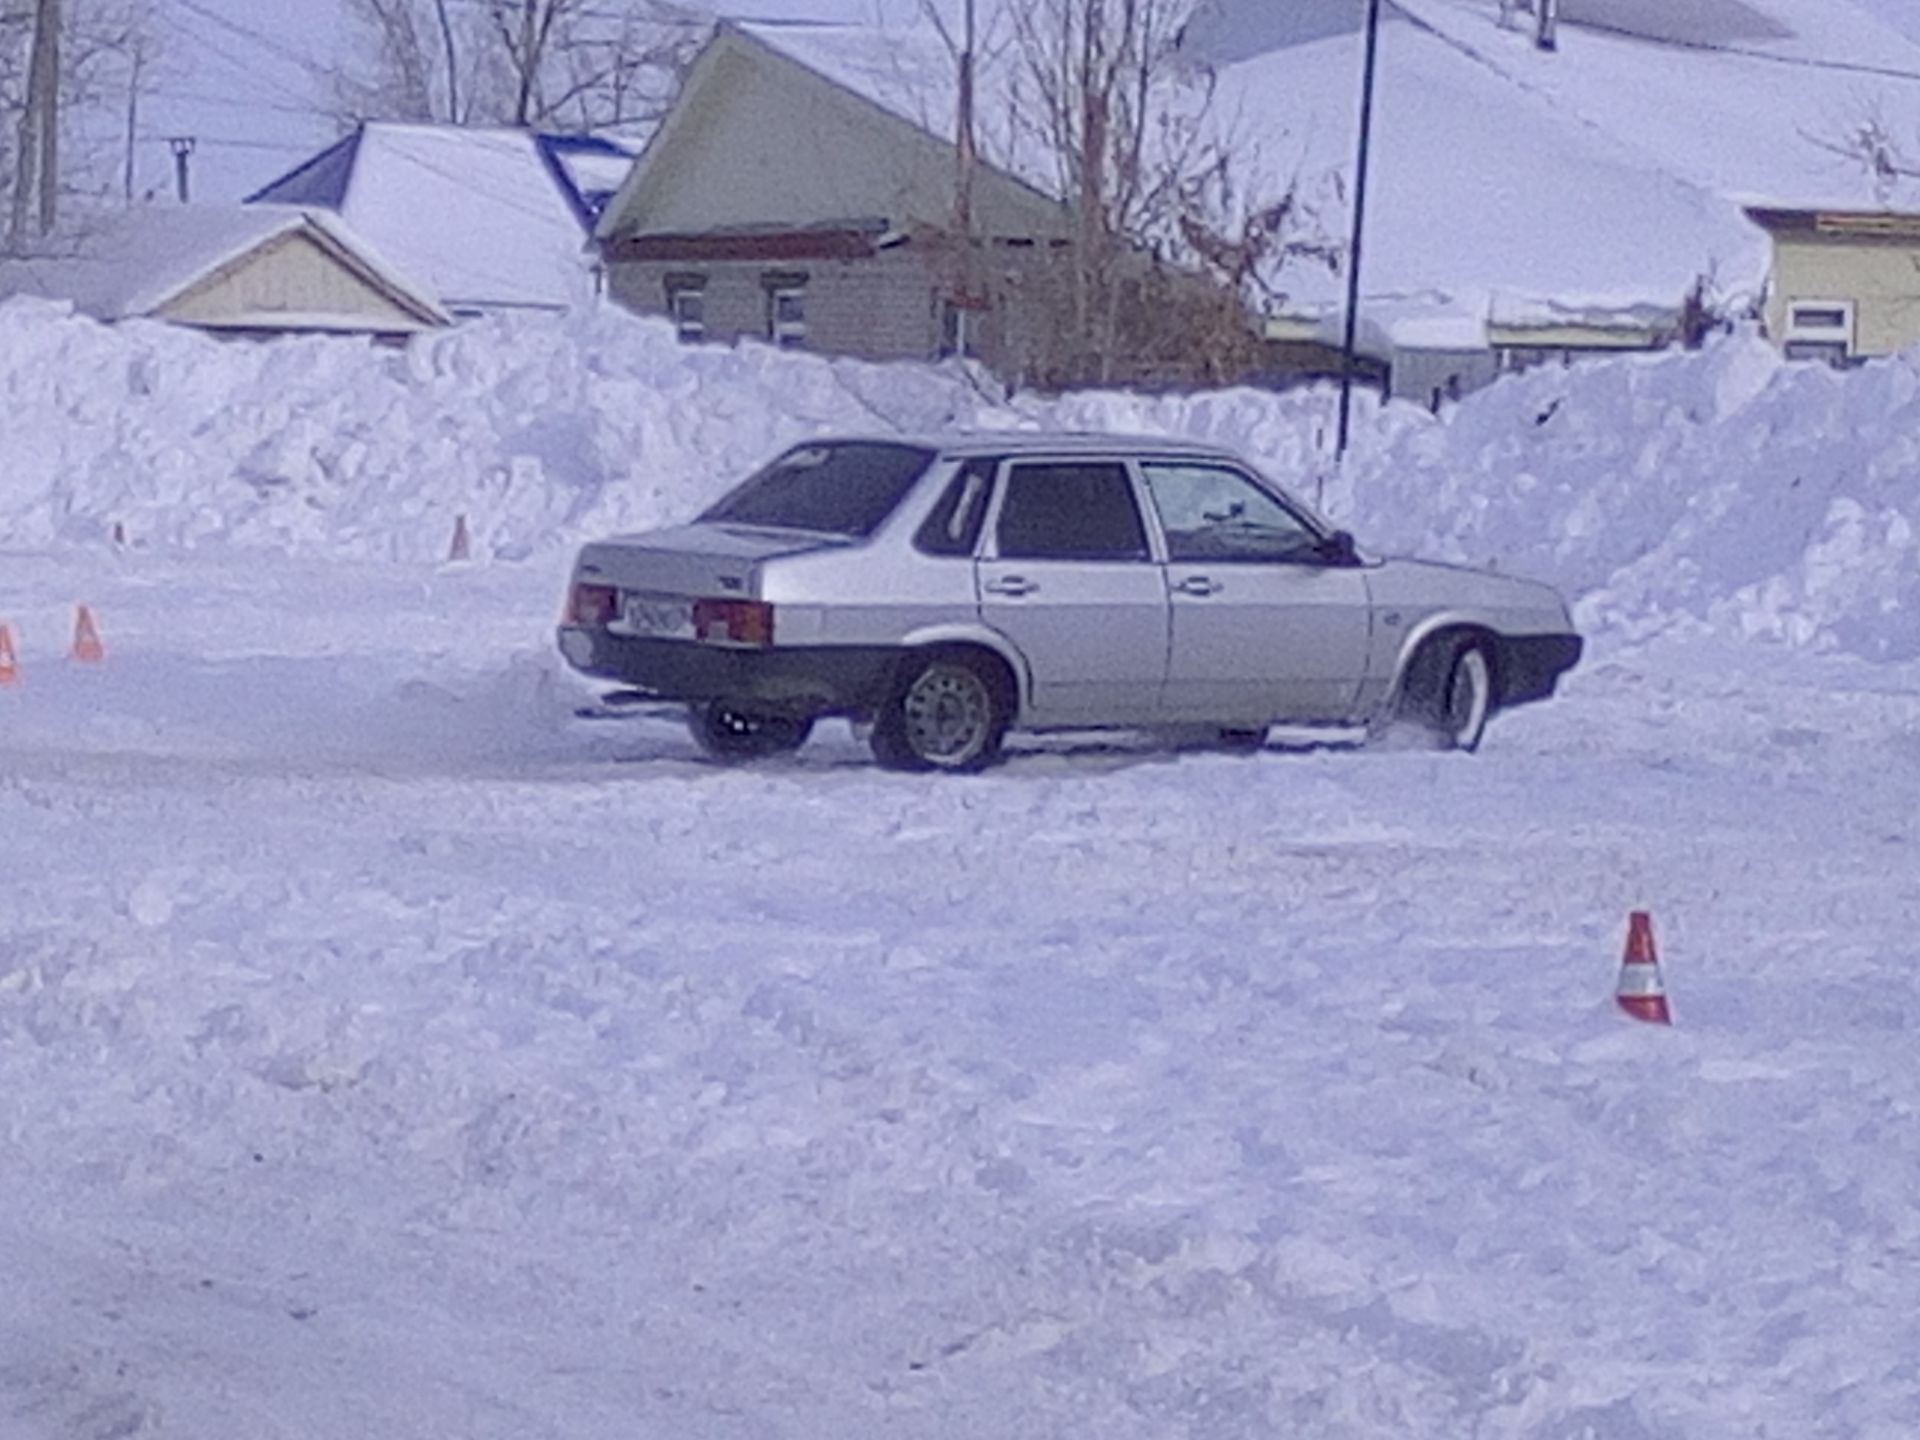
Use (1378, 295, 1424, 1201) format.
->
(0, 301, 1920, 659)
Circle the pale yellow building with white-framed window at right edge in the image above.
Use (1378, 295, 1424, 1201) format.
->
(1747, 207, 1920, 365)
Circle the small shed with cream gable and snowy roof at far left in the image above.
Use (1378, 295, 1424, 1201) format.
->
(0, 205, 451, 340)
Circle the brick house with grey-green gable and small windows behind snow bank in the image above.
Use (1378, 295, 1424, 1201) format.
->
(595, 23, 1069, 378)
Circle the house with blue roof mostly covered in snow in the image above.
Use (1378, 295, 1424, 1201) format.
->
(248, 121, 634, 317)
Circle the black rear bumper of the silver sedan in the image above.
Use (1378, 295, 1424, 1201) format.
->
(559, 626, 899, 714)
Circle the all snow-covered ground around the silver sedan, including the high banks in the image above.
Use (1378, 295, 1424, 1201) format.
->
(0, 305, 1920, 1440)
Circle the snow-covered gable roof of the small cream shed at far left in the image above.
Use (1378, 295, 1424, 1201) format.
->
(0, 205, 451, 332)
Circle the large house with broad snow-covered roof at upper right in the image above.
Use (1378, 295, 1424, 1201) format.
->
(1190, 0, 1920, 396)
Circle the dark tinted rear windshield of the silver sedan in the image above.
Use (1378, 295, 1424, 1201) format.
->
(701, 440, 933, 538)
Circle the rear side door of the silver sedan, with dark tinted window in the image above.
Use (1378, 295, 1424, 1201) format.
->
(973, 457, 1167, 726)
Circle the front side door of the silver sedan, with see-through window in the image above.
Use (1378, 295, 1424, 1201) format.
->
(1140, 459, 1373, 724)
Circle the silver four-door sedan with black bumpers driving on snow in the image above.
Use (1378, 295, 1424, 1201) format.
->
(559, 432, 1580, 770)
